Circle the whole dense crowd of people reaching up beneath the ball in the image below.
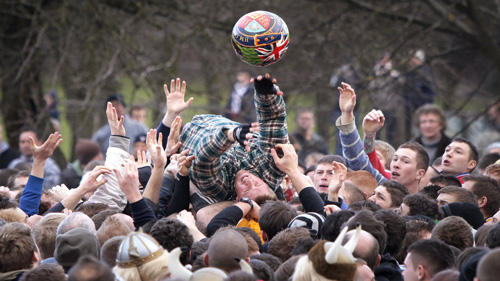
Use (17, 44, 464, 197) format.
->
(0, 73, 500, 281)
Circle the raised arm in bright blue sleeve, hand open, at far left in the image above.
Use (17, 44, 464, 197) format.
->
(19, 132, 62, 216)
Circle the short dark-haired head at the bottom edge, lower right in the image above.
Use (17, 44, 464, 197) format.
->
(408, 239, 455, 277)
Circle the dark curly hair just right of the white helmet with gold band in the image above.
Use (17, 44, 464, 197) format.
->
(149, 218, 194, 265)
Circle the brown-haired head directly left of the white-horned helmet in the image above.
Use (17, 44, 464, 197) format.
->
(268, 224, 311, 262)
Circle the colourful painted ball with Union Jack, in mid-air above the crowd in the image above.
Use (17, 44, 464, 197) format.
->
(231, 11, 290, 66)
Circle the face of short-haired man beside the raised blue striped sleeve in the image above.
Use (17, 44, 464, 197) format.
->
(391, 148, 424, 187)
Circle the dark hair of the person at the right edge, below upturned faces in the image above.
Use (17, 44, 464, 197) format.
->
(463, 176, 500, 217)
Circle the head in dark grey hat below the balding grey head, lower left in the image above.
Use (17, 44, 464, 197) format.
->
(54, 228, 101, 272)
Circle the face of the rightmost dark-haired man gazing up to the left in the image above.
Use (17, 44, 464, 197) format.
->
(441, 141, 476, 175)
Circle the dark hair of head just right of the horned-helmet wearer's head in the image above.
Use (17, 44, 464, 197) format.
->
(375, 210, 406, 256)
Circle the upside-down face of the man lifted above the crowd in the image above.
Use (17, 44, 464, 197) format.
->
(235, 170, 271, 201)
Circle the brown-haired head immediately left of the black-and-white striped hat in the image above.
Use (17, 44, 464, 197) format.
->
(259, 201, 298, 240)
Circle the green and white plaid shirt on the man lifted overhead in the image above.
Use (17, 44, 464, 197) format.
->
(180, 89, 288, 202)
